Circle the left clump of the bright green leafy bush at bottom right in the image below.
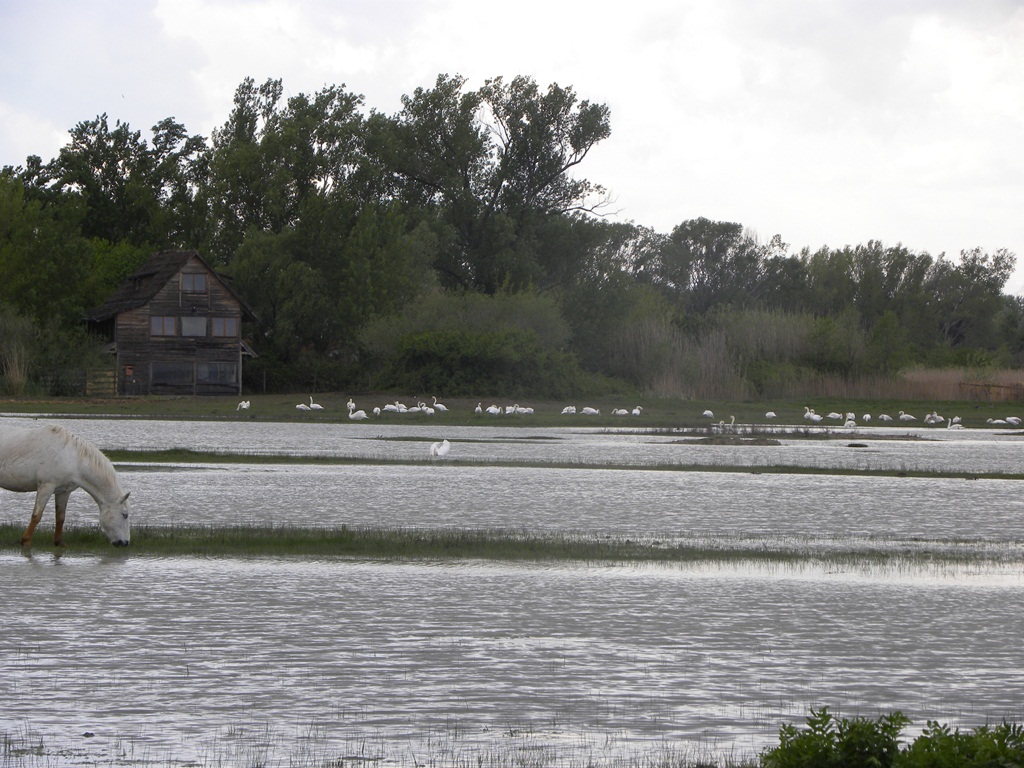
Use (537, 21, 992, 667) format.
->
(761, 707, 910, 768)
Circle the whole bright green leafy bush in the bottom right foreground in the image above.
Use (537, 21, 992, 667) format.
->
(761, 708, 1024, 768)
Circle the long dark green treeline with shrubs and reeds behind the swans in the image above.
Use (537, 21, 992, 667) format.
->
(0, 75, 1024, 398)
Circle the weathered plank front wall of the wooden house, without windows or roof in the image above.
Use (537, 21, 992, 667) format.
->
(115, 259, 242, 394)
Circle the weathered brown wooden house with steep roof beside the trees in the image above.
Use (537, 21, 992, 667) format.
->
(86, 251, 255, 395)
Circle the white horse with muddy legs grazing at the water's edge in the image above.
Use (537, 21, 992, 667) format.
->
(0, 426, 131, 547)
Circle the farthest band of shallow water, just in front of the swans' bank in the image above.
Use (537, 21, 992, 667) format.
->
(4, 418, 1024, 474)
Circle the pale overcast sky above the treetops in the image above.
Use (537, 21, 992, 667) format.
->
(6, 0, 1024, 293)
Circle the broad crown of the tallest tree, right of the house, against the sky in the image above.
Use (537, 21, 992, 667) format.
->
(368, 75, 610, 294)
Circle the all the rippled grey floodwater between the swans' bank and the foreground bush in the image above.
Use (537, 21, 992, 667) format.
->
(0, 420, 1024, 766)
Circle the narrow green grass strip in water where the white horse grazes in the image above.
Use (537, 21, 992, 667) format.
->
(0, 523, 1022, 567)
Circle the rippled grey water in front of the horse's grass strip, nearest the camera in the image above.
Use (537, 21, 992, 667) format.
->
(6, 554, 1024, 765)
